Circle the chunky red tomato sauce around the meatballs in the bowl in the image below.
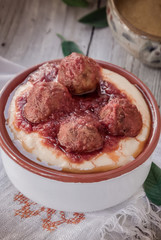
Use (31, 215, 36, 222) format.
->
(15, 69, 126, 163)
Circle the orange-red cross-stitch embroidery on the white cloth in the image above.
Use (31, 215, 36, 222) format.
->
(14, 193, 85, 232)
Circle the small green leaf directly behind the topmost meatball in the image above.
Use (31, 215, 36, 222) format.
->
(62, 41, 83, 56)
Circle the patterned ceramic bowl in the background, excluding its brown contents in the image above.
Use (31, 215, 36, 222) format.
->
(107, 0, 161, 68)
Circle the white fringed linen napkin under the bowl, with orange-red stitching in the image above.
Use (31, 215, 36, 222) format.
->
(0, 57, 161, 240)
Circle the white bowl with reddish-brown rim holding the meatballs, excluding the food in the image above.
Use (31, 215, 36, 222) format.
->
(0, 60, 160, 212)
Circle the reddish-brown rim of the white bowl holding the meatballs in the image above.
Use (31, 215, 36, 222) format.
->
(0, 60, 161, 183)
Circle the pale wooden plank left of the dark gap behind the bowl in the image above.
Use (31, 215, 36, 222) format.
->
(0, 0, 97, 66)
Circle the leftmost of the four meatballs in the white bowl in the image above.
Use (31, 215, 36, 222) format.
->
(24, 82, 72, 123)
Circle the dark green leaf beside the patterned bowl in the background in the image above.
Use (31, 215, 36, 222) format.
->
(78, 7, 108, 28)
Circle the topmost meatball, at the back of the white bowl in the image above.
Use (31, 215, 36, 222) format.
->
(58, 53, 100, 95)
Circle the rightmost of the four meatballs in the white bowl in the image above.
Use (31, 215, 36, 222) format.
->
(100, 98, 142, 137)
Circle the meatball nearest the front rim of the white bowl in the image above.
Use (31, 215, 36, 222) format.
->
(58, 116, 104, 153)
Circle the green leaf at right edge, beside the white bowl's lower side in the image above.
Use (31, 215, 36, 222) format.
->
(143, 163, 161, 206)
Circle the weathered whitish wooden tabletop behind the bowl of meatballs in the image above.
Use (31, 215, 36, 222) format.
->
(0, 0, 161, 239)
